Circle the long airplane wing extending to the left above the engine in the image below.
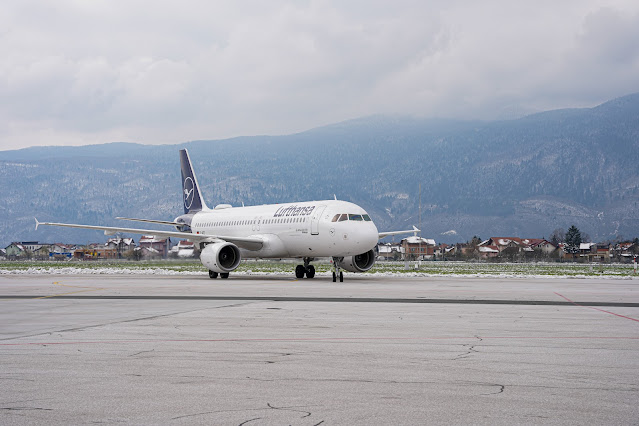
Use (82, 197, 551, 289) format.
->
(35, 219, 264, 250)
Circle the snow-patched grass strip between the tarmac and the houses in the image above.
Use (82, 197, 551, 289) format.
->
(0, 261, 639, 279)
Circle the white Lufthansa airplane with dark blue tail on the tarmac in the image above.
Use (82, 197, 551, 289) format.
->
(35, 149, 419, 282)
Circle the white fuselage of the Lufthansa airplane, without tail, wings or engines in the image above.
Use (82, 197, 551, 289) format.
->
(191, 200, 379, 258)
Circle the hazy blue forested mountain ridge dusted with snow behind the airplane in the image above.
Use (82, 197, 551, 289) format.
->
(0, 94, 639, 246)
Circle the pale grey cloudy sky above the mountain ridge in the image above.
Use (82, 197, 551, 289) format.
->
(0, 0, 639, 150)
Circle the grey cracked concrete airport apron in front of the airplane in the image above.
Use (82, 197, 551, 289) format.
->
(0, 274, 639, 425)
